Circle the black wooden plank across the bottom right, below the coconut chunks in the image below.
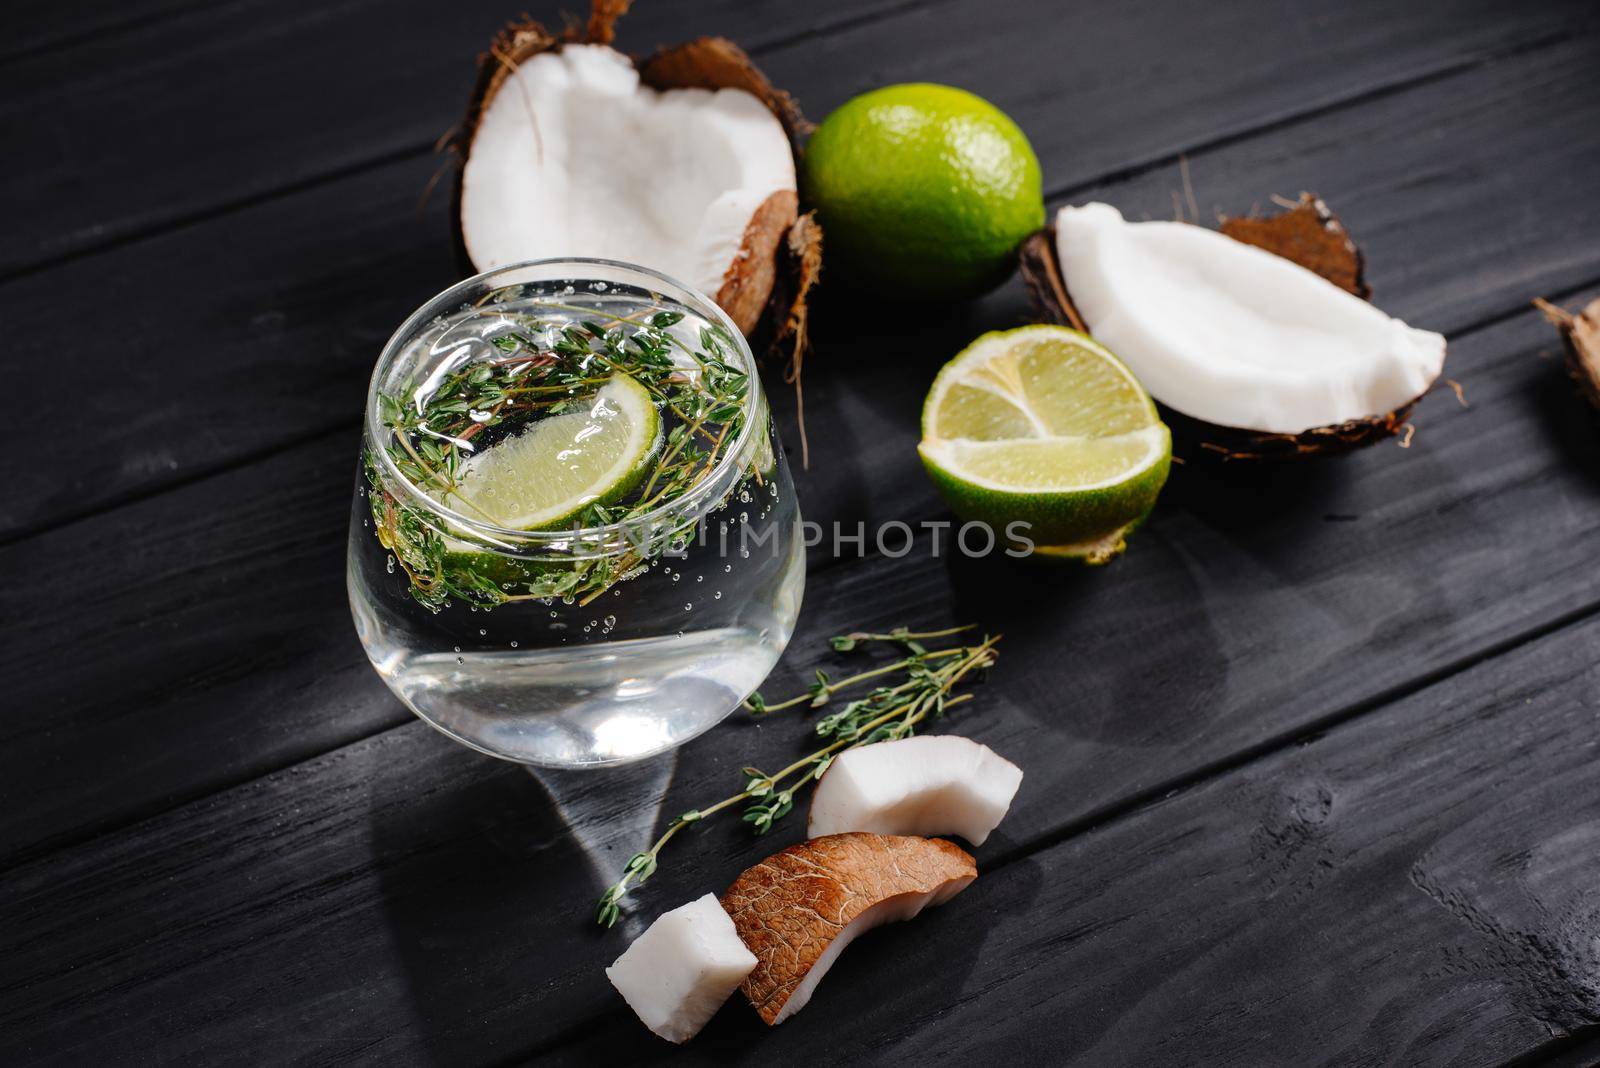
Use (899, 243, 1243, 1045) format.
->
(547, 620, 1600, 1065)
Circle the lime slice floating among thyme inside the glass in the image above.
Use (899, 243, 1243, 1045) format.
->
(443, 374, 661, 531)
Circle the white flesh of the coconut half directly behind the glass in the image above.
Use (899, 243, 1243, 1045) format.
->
(461, 43, 797, 331)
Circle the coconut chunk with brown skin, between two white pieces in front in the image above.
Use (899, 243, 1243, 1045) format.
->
(722, 833, 978, 1025)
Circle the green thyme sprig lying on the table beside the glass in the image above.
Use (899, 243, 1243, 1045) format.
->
(595, 627, 1000, 927)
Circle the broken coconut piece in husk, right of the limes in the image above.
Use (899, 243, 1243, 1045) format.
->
(1022, 193, 1445, 459)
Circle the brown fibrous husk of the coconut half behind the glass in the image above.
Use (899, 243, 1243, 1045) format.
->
(450, 0, 821, 389)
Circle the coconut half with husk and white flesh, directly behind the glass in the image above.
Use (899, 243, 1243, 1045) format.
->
(456, 0, 821, 343)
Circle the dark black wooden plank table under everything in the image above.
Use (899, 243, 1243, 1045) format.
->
(0, 0, 1600, 1065)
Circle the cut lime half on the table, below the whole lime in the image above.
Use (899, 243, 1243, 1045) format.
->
(918, 326, 1171, 563)
